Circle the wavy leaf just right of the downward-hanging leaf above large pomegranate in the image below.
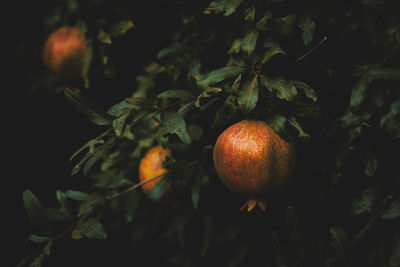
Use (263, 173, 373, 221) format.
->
(262, 76, 297, 102)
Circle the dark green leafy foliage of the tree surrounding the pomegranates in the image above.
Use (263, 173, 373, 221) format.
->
(20, 0, 400, 266)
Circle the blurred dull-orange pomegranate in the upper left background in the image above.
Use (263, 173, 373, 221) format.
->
(43, 26, 87, 80)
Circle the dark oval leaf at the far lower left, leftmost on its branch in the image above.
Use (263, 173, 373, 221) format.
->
(22, 189, 51, 234)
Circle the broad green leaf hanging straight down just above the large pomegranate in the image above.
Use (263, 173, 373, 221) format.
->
(237, 75, 259, 114)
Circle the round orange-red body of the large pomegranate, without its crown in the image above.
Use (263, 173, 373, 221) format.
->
(213, 120, 295, 196)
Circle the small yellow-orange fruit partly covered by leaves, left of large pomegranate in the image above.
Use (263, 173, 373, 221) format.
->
(139, 146, 171, 194)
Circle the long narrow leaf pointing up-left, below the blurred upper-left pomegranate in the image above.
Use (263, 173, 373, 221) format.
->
(64, 89, 114, 125)
